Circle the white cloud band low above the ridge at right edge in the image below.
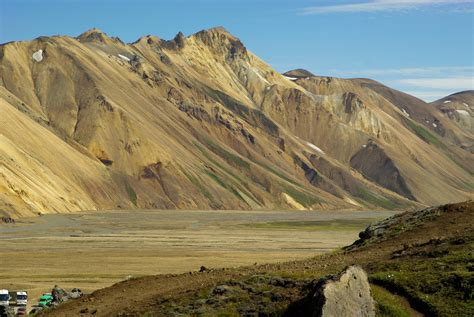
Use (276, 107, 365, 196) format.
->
(397, 77, 474, 90)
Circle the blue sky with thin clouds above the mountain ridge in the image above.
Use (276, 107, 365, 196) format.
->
(0, 0, 474, 101)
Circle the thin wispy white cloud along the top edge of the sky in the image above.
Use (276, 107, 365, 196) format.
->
(301, 0, 474, 14)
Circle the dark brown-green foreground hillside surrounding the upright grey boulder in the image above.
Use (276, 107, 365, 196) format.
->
(43, 201, 474, 316)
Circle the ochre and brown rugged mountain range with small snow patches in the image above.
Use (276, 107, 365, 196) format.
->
(0, 28, 474, 217)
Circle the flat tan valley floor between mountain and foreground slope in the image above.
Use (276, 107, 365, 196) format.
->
(0, 211, 393, 304)
